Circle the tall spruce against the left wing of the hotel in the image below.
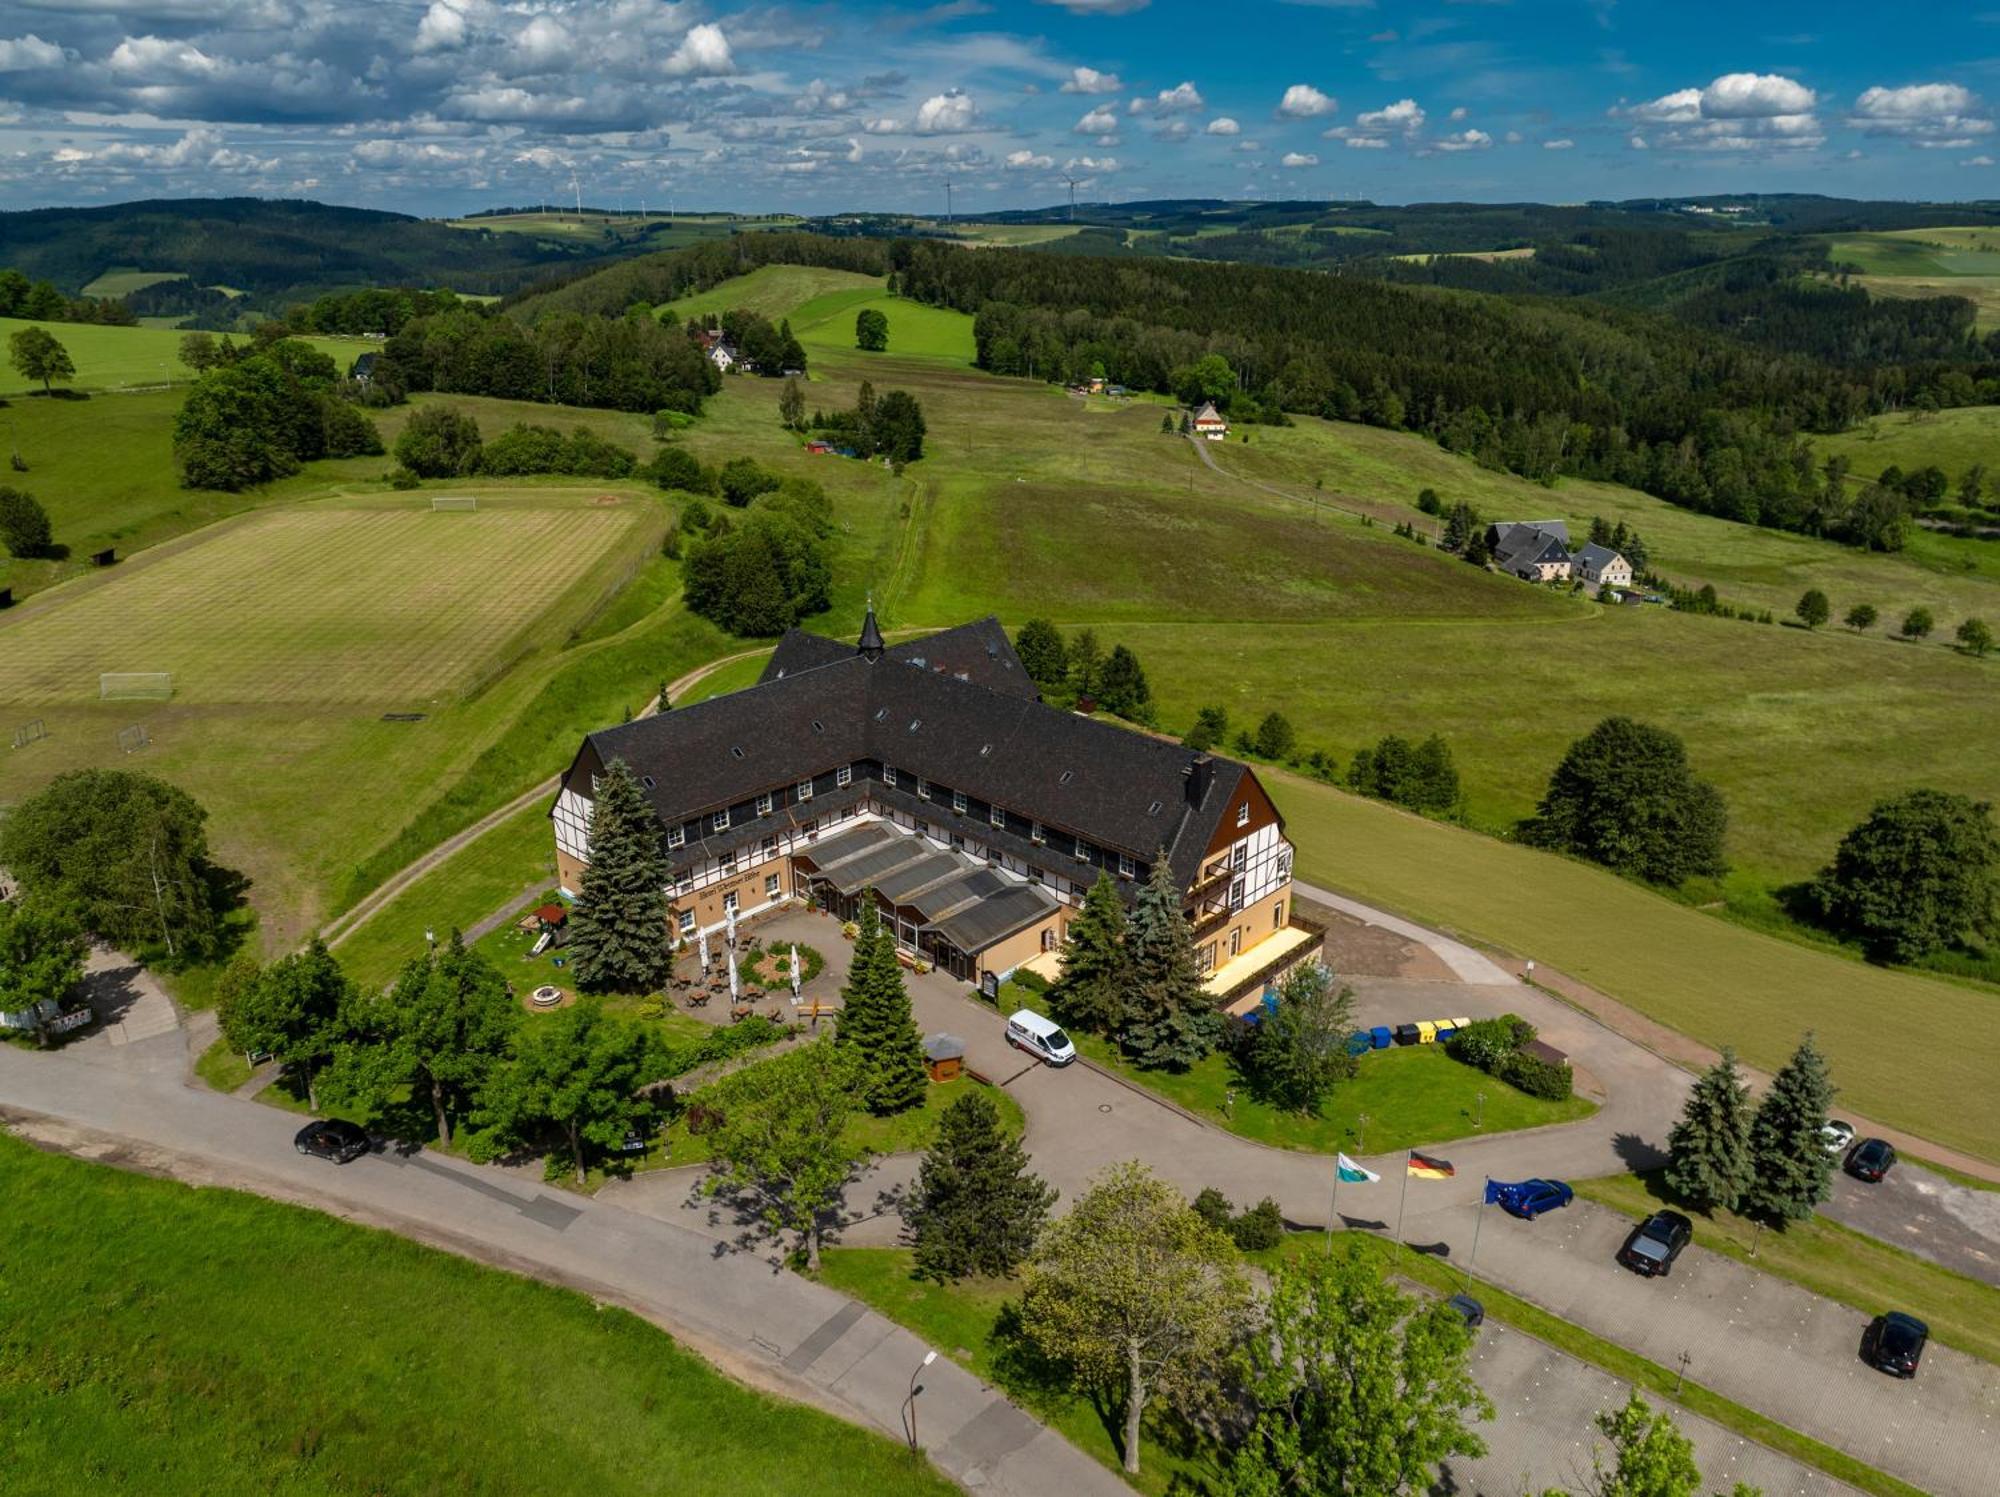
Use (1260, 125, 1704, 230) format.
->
(570, 759, 668, 993)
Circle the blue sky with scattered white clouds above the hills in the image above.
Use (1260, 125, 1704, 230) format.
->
(0, 0, 2000, 214)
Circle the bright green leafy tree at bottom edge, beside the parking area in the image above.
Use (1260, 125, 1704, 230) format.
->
(1224, 1253, 1494, 1497)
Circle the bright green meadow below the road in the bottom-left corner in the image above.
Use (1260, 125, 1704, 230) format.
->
(0, 1139, 954, 1497)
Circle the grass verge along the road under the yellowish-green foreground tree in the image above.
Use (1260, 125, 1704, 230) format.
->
(820, 1247, 1218, 1495)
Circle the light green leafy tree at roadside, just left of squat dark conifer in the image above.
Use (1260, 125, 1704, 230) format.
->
(702, 1035, 862, 1271)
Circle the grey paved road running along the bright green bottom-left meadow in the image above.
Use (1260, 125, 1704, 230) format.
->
(0, 1037, 1128, 1497)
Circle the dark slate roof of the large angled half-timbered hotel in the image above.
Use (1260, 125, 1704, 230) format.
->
(586, 620, 1250, 885)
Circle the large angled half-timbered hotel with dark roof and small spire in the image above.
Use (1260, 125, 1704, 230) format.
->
(550, 608, 1320, 1005)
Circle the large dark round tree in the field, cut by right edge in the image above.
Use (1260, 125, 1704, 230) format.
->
(1812, 791, 2000, 961)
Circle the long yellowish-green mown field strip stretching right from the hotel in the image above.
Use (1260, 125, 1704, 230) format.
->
(1264, 773, 2000, 1159)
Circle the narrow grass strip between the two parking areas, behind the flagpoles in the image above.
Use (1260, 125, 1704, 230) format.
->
(1252, 1233, 1922, 1497)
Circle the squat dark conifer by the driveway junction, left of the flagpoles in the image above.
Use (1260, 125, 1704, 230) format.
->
(906, 1087, 1056, 1281)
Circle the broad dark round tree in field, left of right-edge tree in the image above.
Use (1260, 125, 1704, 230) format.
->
(1520, 716, 1728, 885)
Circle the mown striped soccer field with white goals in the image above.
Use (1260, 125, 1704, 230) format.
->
(0, 498, 640, 706)
